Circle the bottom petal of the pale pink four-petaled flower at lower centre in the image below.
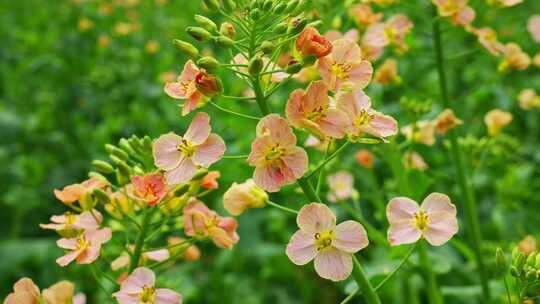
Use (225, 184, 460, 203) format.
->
(315, 248, 353, 281)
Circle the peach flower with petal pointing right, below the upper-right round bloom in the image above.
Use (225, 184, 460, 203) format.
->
(336, 91, 397, 138)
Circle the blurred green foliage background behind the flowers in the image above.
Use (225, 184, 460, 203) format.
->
(0, 0, 540, 303)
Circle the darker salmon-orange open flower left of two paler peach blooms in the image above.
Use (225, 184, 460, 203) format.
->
(285, 80, 349, 138)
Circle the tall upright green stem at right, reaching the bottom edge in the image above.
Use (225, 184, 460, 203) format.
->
(433, 7, 491, 302)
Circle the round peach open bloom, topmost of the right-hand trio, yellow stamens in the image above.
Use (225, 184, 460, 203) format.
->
(317, 39, 373, 92)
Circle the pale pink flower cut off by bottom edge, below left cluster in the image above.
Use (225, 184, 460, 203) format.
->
(113, 267, 182, 304)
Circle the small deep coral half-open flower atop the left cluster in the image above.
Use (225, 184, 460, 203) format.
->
(131, 173, 167, 206)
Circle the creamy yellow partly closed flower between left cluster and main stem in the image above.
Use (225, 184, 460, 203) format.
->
(223, 179, 268, 216)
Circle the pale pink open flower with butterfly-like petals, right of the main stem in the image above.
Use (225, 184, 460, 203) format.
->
(386, 193, 458, 246)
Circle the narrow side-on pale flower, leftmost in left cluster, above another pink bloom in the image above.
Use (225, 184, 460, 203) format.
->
(39, 209, 103, 237)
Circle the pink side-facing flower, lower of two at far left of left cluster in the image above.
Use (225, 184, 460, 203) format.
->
(56, 228, 111, 267)
